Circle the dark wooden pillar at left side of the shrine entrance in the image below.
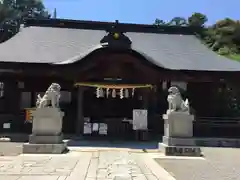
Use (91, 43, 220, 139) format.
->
(76, 87, 84, 135)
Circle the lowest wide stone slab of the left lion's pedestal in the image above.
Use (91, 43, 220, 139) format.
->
(23, 143, 67, 154)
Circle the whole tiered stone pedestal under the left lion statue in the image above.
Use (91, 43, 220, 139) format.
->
(23, 107, 67, 154)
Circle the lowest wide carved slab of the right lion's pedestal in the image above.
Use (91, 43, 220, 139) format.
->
(158, 143, 202, 157)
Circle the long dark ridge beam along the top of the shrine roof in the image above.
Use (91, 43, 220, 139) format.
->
(25, 19, 202, 34)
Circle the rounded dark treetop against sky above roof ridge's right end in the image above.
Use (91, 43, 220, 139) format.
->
(188, 13, 208, 27)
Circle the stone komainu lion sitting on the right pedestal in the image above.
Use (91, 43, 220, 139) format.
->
(167, 86, 189, 113)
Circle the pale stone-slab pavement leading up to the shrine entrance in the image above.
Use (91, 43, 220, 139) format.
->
(0, 150, 173, 180)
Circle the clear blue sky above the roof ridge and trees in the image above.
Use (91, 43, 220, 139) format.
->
(43, 0, 240, 24)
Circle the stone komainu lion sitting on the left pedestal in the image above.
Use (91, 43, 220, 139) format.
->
(36, 83, 61, 108)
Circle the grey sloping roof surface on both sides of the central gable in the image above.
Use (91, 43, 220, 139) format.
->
(0, 24, 240, 71)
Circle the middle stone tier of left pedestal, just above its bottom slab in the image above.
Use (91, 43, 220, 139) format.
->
(29, 134, 63, 144)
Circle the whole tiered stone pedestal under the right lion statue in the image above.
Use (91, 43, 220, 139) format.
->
(159, 112, 201, 156)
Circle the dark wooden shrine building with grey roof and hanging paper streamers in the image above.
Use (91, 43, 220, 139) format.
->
(0, 19, 240, 139)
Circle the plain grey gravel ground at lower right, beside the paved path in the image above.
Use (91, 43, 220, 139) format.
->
(156, 148, 240, 180)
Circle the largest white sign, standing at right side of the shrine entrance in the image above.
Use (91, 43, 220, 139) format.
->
(133, 109, 148, 130)
